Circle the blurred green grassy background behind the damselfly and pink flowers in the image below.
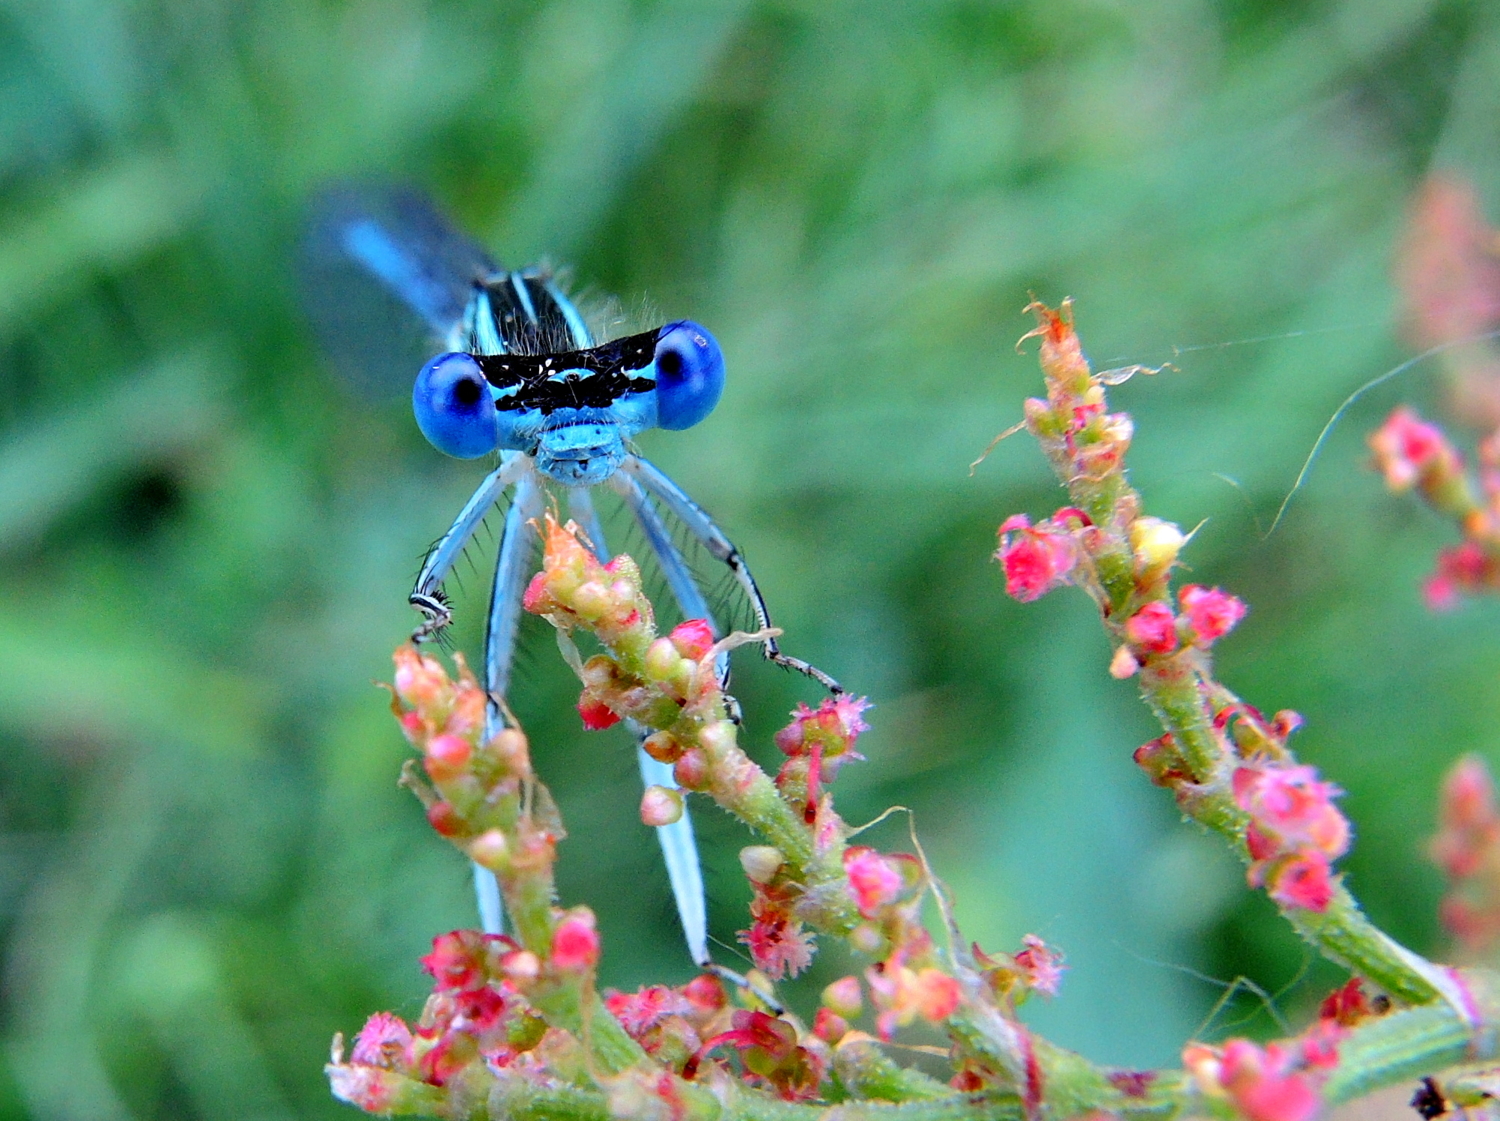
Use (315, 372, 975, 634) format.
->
(0, 0, 1500, 1121)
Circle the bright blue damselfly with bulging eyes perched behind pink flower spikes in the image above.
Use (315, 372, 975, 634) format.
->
(314, 192, 839, 966)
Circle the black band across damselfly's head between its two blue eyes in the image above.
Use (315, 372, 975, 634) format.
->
(474, 330, 660, 416)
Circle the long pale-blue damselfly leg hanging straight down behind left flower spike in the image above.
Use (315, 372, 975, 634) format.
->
(474, 456, 542, 933)
